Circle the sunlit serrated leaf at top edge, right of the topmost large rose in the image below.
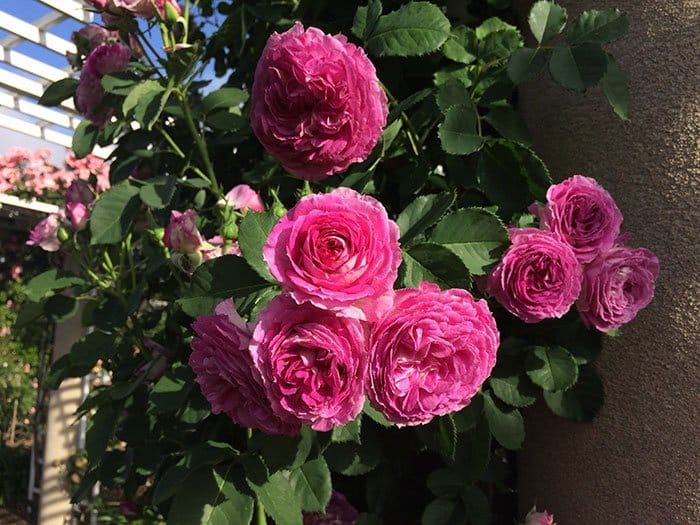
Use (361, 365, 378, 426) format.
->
(365, 2, 450, 57)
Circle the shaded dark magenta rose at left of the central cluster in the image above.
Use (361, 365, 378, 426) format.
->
(189, 299, 299, 435)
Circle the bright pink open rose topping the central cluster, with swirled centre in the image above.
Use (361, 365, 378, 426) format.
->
(263, 188, 401, 320)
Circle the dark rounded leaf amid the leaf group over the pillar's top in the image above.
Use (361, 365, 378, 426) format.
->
(549, 44, 608, 92)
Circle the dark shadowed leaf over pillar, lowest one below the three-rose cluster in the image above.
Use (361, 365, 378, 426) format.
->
(544, 365, 605, 421)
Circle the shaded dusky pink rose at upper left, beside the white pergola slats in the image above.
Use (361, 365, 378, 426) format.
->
(75, 44, 131, 128)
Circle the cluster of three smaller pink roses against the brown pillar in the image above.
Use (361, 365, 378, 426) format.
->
(487, 175, 659, 331)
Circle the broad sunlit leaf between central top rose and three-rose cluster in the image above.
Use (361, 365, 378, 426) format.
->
(428, 208, 508, 275)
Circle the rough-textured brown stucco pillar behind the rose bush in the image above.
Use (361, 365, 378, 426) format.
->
(519, 0, 700, 525)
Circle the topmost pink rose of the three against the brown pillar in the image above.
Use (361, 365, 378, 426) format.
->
(538, 175, 622, 264)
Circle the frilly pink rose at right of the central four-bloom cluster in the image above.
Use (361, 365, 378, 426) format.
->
(367, 282, 499, 426)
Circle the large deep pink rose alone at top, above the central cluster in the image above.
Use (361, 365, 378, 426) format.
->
(250, 22, 388, 180)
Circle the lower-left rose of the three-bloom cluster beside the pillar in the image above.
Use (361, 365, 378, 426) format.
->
(486, 228, 581, 323)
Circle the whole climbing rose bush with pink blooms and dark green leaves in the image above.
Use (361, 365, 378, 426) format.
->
(27, 0, 658, 525)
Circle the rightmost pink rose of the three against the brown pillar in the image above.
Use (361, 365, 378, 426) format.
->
(577, 246, 659, 332)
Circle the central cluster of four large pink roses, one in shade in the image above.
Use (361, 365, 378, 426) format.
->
(190, 188, 499, 434)
